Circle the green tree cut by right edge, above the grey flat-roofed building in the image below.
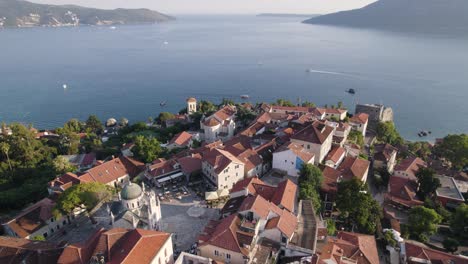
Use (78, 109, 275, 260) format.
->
(435, 134, 468, 169)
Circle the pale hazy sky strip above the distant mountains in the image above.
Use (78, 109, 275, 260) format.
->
(30, 0, 375, 14)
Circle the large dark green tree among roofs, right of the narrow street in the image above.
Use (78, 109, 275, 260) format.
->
(336, 178, 382, 234)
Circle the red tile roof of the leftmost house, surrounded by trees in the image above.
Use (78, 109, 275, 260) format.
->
(6, 198, 55, 238)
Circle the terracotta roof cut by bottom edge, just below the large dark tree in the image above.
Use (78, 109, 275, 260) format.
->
(320, 232, 379, 264)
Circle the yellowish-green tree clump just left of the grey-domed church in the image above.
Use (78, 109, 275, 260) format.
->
(53, 182, 113, 218)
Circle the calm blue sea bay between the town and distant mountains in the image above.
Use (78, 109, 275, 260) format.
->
(0, 15, 468, 140)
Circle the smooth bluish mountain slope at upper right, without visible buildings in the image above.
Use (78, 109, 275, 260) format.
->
(304, 0, 468, 34)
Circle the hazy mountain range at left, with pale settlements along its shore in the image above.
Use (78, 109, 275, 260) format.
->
(0, 0, 173, 27)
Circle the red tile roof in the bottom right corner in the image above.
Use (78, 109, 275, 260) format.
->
(405, 242, 468, 264)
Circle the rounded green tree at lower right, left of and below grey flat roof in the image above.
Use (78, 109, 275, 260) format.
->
(408, 206, 442, 242)
